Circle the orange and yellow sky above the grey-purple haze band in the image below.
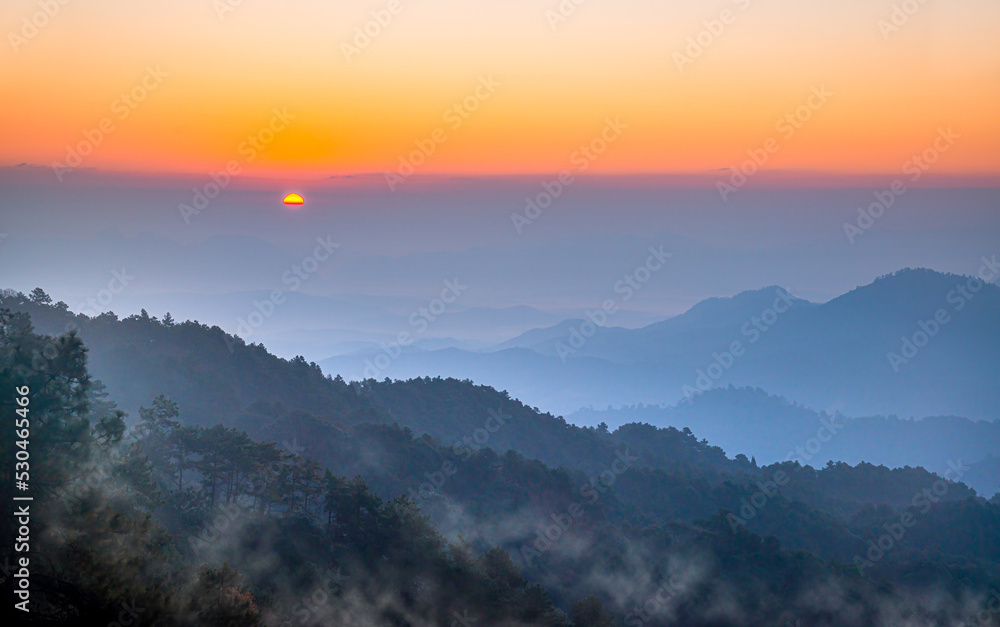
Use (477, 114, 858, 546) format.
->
(0, 0, 1000, 177)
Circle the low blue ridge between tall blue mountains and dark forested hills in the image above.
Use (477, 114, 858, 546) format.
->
(567, 388, 1000, 495)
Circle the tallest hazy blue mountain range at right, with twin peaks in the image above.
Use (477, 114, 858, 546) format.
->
(320, 269, 1000, 419)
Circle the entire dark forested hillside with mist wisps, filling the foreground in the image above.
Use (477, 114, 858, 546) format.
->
(0, 294, 1000, 627)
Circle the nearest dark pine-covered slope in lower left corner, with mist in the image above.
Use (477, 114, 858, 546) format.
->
(0, 309, 584, 627)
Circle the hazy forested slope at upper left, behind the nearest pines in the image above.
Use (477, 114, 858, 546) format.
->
(0, 290, 385, 426)
